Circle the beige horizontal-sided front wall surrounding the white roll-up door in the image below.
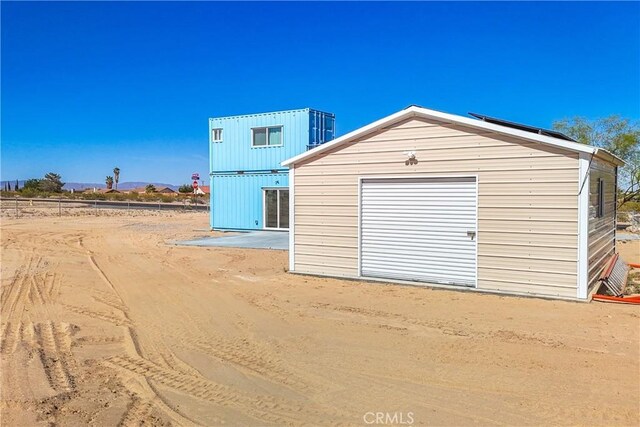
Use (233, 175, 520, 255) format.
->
(294, 119, 578, 298)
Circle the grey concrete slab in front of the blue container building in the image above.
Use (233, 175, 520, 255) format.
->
(171, 230, 289, 250)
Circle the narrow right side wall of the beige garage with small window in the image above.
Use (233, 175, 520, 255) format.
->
(588, 159, 616, 291)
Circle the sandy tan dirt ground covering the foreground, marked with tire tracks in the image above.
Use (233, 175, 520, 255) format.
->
(0, 213, 640, 426)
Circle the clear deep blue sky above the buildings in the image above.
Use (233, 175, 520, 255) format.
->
(1, 2, 640, 184)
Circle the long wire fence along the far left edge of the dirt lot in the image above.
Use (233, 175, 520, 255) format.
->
(0, 197, 210, 218)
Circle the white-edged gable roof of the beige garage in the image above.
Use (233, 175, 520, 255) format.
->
(281, 105, 624, 166)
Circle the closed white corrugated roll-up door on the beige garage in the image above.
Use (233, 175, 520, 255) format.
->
(360, 177, 477, 286)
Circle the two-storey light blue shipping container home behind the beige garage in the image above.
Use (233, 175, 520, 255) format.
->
(209, 108, 335, 230)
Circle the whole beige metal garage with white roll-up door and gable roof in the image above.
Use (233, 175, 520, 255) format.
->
(283, 106, 623, 300)
